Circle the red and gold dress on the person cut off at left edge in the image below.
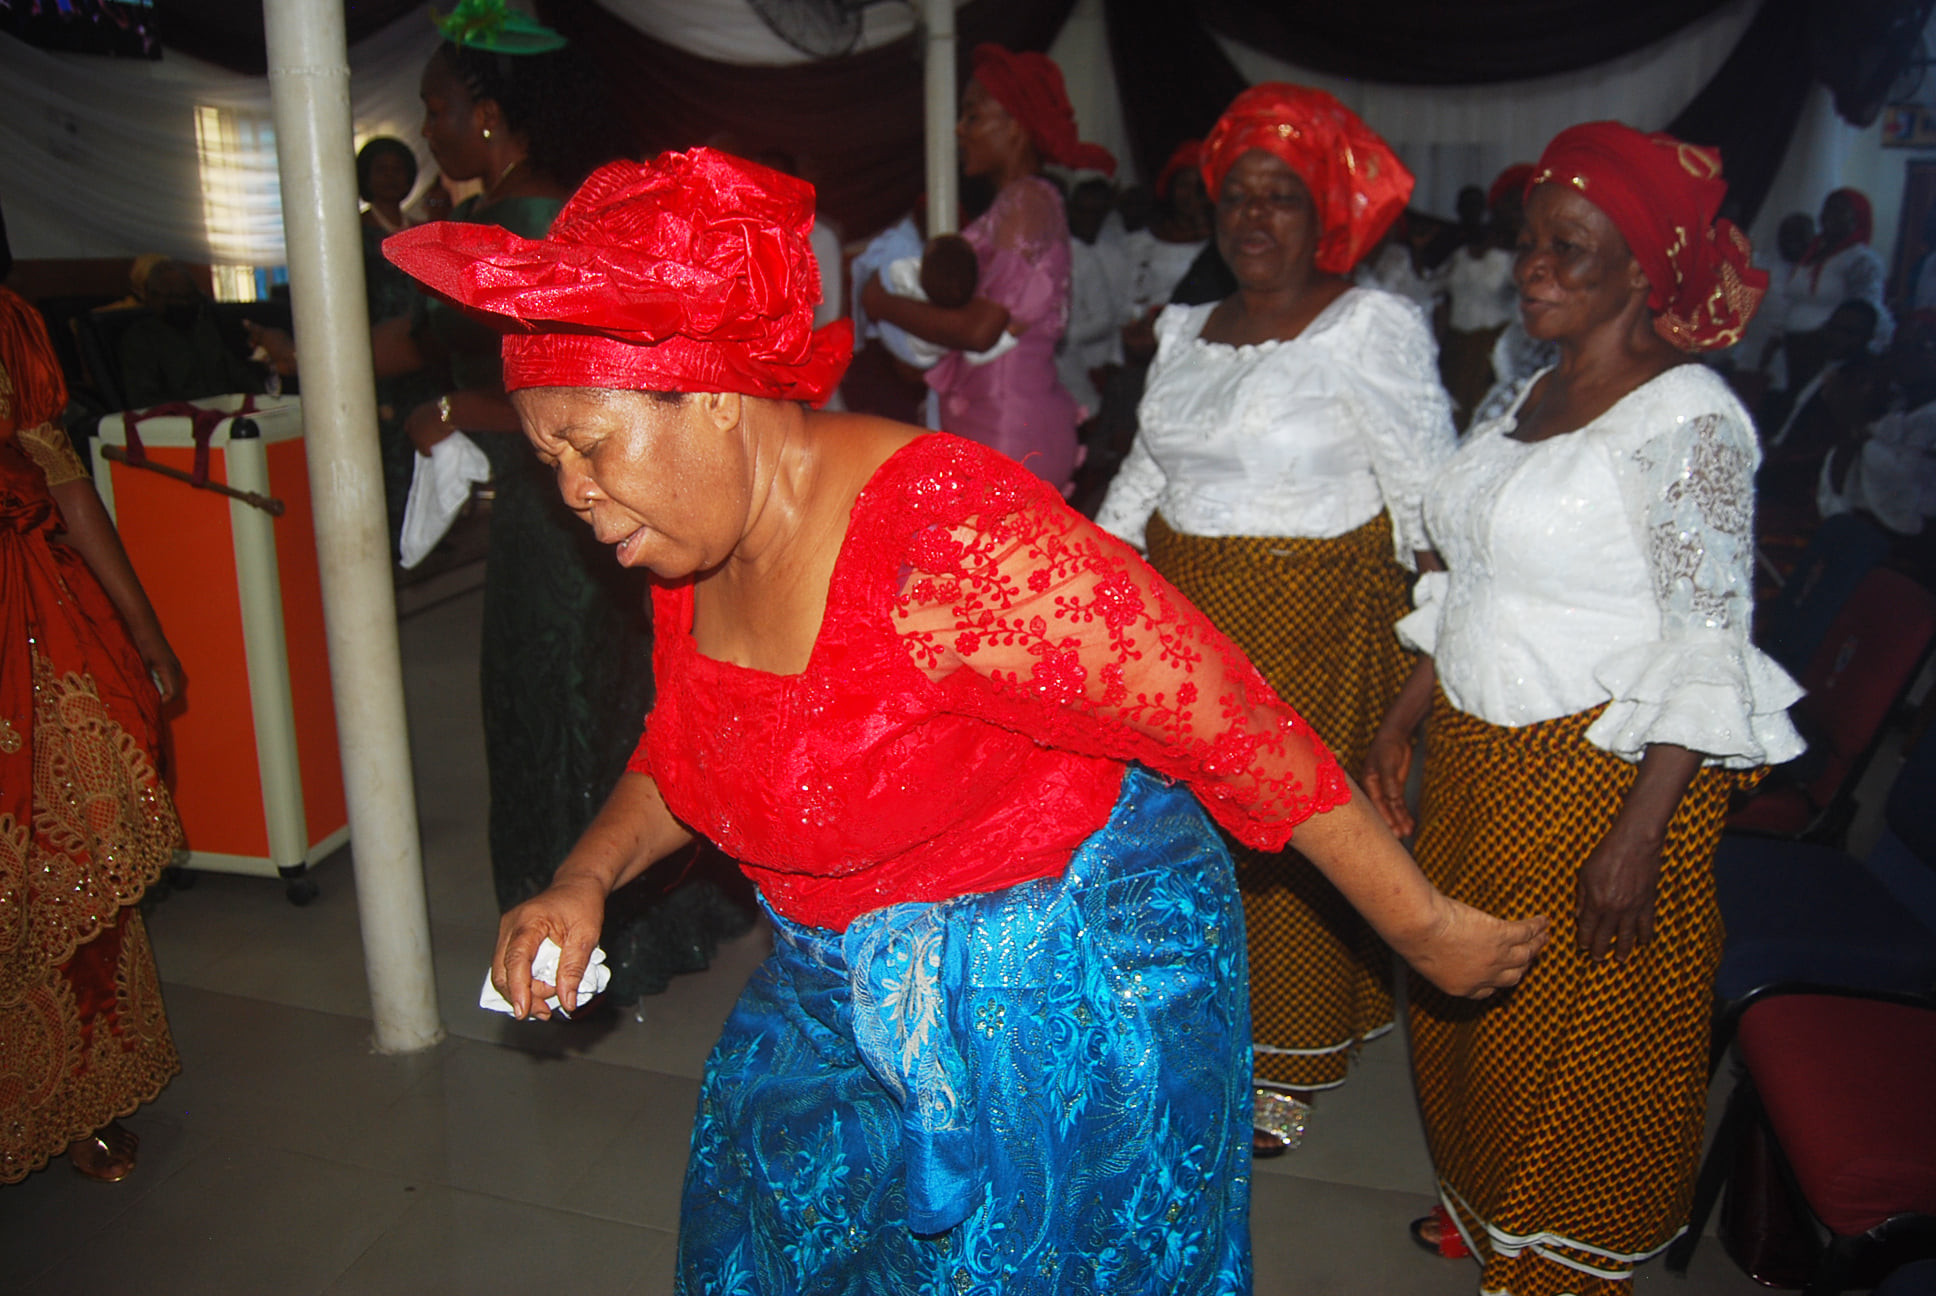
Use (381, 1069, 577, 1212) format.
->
(0, 289, 182, 1184)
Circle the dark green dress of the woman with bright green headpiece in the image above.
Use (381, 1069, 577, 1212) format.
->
(424, 198, 753, 1003)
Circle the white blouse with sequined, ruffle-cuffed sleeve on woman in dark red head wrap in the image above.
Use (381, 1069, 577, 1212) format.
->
(1398, 364, 1802, 769)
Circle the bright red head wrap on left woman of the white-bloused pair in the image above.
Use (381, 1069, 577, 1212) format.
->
(1204, 81, 1413, 275)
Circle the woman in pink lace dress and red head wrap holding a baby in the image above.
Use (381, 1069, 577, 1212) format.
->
(862, 45, 1115, 488)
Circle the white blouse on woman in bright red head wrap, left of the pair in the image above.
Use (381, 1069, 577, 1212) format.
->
(1096, 287, 1454, 568)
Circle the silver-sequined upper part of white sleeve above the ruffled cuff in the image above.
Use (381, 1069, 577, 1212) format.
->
(1634, 415, 1754, 639)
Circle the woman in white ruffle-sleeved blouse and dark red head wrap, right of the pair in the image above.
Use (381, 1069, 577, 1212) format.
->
(1367, 122, 1800, 1296)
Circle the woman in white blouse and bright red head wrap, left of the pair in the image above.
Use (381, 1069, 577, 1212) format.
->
(1096, 85, 1452, 1155)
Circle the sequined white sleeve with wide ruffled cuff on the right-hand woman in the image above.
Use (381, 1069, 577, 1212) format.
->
(1586, 366, 1802, 769)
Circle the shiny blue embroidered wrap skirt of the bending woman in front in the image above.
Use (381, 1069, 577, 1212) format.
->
(678, 769, 1251, 1296)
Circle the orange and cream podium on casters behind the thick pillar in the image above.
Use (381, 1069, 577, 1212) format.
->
(95, 395, 348, 905)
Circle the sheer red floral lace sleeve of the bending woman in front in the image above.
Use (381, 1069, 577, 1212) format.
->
(892, 445, 1349, 849)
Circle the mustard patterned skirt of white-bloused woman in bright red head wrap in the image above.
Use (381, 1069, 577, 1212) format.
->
(1148, 513, 1413, 1089)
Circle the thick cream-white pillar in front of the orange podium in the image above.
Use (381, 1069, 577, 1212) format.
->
(263, 0, 443, 1054)
